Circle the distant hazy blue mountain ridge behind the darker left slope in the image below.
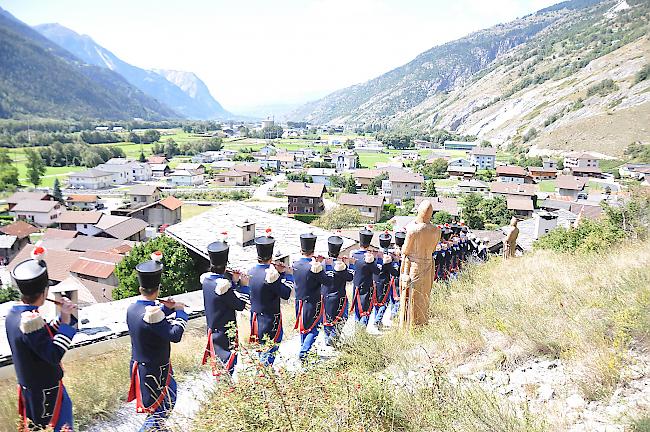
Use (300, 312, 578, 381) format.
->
(34, 23, 232, 120)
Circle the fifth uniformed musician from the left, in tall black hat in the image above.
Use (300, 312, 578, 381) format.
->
(293, 233, 325, 361)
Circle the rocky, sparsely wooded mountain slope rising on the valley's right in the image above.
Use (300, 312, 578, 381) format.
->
(294, 0, 650, 154)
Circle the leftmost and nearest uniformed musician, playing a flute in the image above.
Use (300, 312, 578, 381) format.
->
(5, 246, 76, 432)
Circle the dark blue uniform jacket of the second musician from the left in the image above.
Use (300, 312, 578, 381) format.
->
(126, 299, 188, 413)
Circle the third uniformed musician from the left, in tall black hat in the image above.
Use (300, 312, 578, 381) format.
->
(200, 233, 248, 377)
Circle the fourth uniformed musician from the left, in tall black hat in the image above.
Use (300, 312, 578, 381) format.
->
(248, 228, 294, 366)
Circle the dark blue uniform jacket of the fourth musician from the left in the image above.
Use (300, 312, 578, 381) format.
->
(248, 264, 294, 342)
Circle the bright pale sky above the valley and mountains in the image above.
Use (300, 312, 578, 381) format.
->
(0, 0, 559, 112)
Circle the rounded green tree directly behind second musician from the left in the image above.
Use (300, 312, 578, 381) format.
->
(113, 236, 199, 300)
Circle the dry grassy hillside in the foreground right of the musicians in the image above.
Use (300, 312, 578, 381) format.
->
(193, 242, 650, 432)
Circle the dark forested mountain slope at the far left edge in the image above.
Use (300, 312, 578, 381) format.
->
(0, 8, 178, 120)
